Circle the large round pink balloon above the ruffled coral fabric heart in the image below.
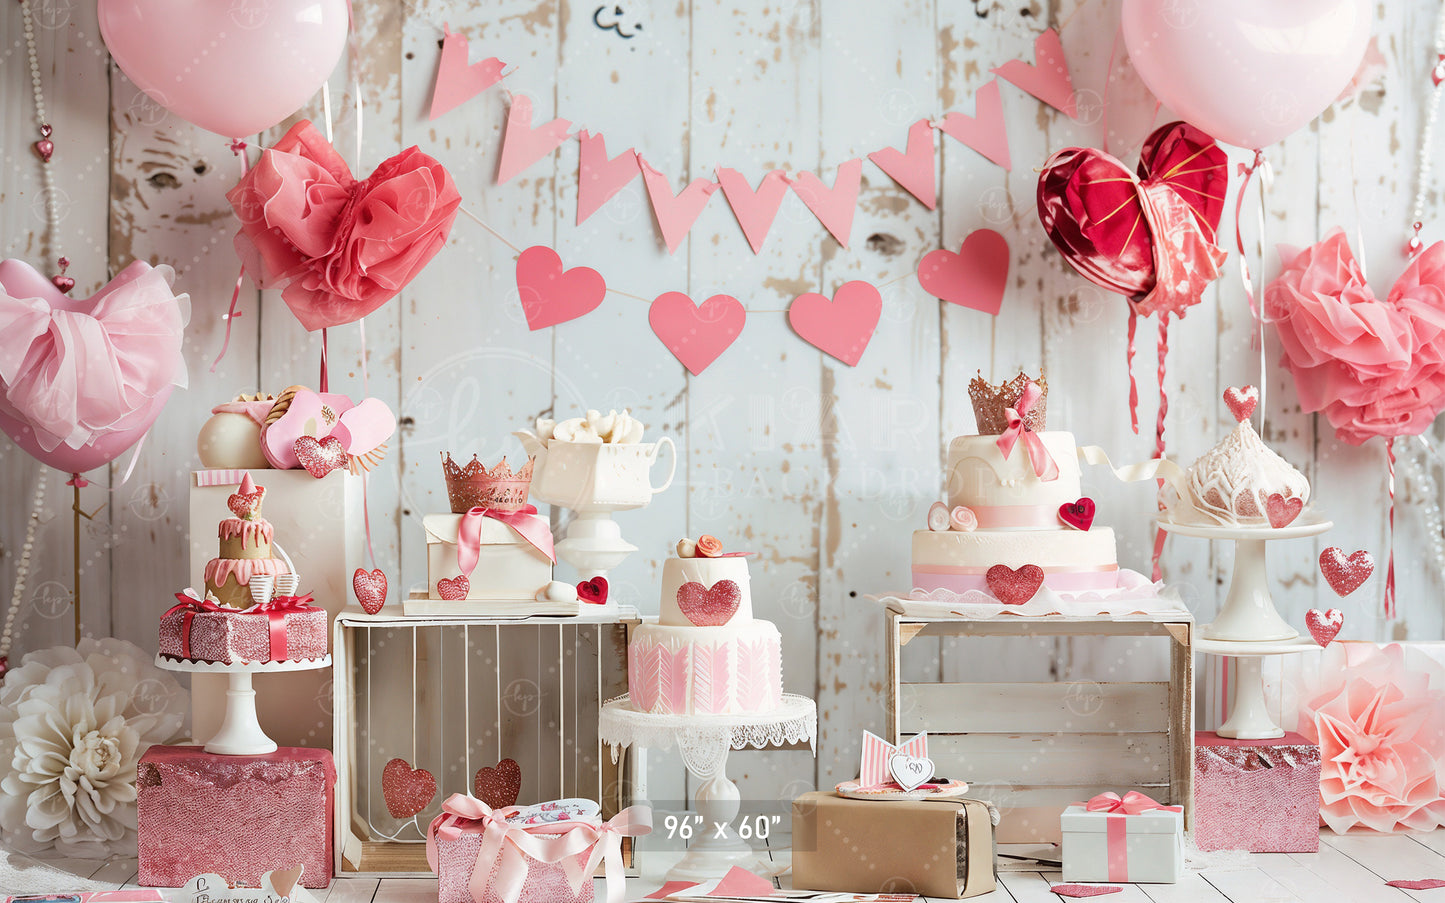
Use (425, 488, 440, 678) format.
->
(100, 0, 347, 137)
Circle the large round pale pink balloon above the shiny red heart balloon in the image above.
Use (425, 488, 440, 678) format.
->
(1123, 0, 1371, 149)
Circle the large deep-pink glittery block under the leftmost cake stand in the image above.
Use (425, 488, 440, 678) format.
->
(136, 746, 337, 887)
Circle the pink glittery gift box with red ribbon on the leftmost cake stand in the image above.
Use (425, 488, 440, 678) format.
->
(160, 608, 327, 665)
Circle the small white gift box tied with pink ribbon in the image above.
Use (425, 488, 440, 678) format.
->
(1059, 790, 1183, 884)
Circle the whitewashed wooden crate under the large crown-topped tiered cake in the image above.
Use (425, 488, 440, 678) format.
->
(887, 611, 1194, 844)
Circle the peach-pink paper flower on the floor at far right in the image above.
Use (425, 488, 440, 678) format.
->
(1299, 643, 1445, 831)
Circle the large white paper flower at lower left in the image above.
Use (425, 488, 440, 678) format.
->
(0, 639, 189, 858)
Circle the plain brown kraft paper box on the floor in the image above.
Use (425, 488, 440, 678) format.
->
(793, 792, 994, 900)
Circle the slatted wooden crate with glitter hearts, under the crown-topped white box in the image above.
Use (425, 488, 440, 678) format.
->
(331, 607, 639, 876)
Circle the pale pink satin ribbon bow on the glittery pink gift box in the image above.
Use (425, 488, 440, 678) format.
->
(426, 793, 652, 903)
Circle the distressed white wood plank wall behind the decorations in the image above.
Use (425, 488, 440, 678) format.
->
(0, 0, 1442, 800)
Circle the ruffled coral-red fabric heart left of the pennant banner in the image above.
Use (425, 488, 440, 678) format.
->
(225, 120, 461, 329)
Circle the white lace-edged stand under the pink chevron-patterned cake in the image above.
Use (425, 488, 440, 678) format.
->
(597, 694, 818, 881)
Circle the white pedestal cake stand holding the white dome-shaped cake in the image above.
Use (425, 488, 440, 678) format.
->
(1159, 513, 1334, 643)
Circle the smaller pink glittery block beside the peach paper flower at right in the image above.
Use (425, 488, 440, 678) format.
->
(1194, 733, 1319, 852)
